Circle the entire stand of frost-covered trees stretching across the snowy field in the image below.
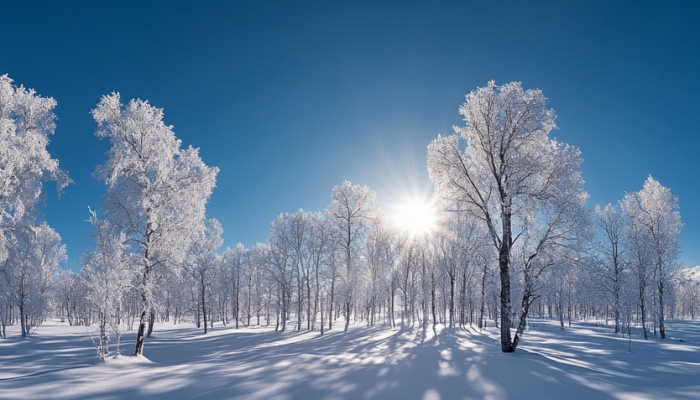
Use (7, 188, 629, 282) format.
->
(0, 75, 700, 360)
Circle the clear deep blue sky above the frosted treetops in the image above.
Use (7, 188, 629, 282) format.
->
(0, 0, 700, 269)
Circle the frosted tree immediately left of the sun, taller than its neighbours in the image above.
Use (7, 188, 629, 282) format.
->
(327, 181, 380, 331)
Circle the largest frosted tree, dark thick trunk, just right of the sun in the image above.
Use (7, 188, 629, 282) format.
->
(428, 81, 587, 352)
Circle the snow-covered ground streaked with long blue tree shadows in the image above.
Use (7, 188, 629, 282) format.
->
(0, 321, 700, 399)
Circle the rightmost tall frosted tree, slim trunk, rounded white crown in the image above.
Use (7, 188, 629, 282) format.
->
(622, 176, 683, 339)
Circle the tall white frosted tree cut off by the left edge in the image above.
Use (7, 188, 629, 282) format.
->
(0, 75, 71, 336)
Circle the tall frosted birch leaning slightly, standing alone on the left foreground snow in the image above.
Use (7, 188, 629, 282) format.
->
(92, 93, 218, 355)
